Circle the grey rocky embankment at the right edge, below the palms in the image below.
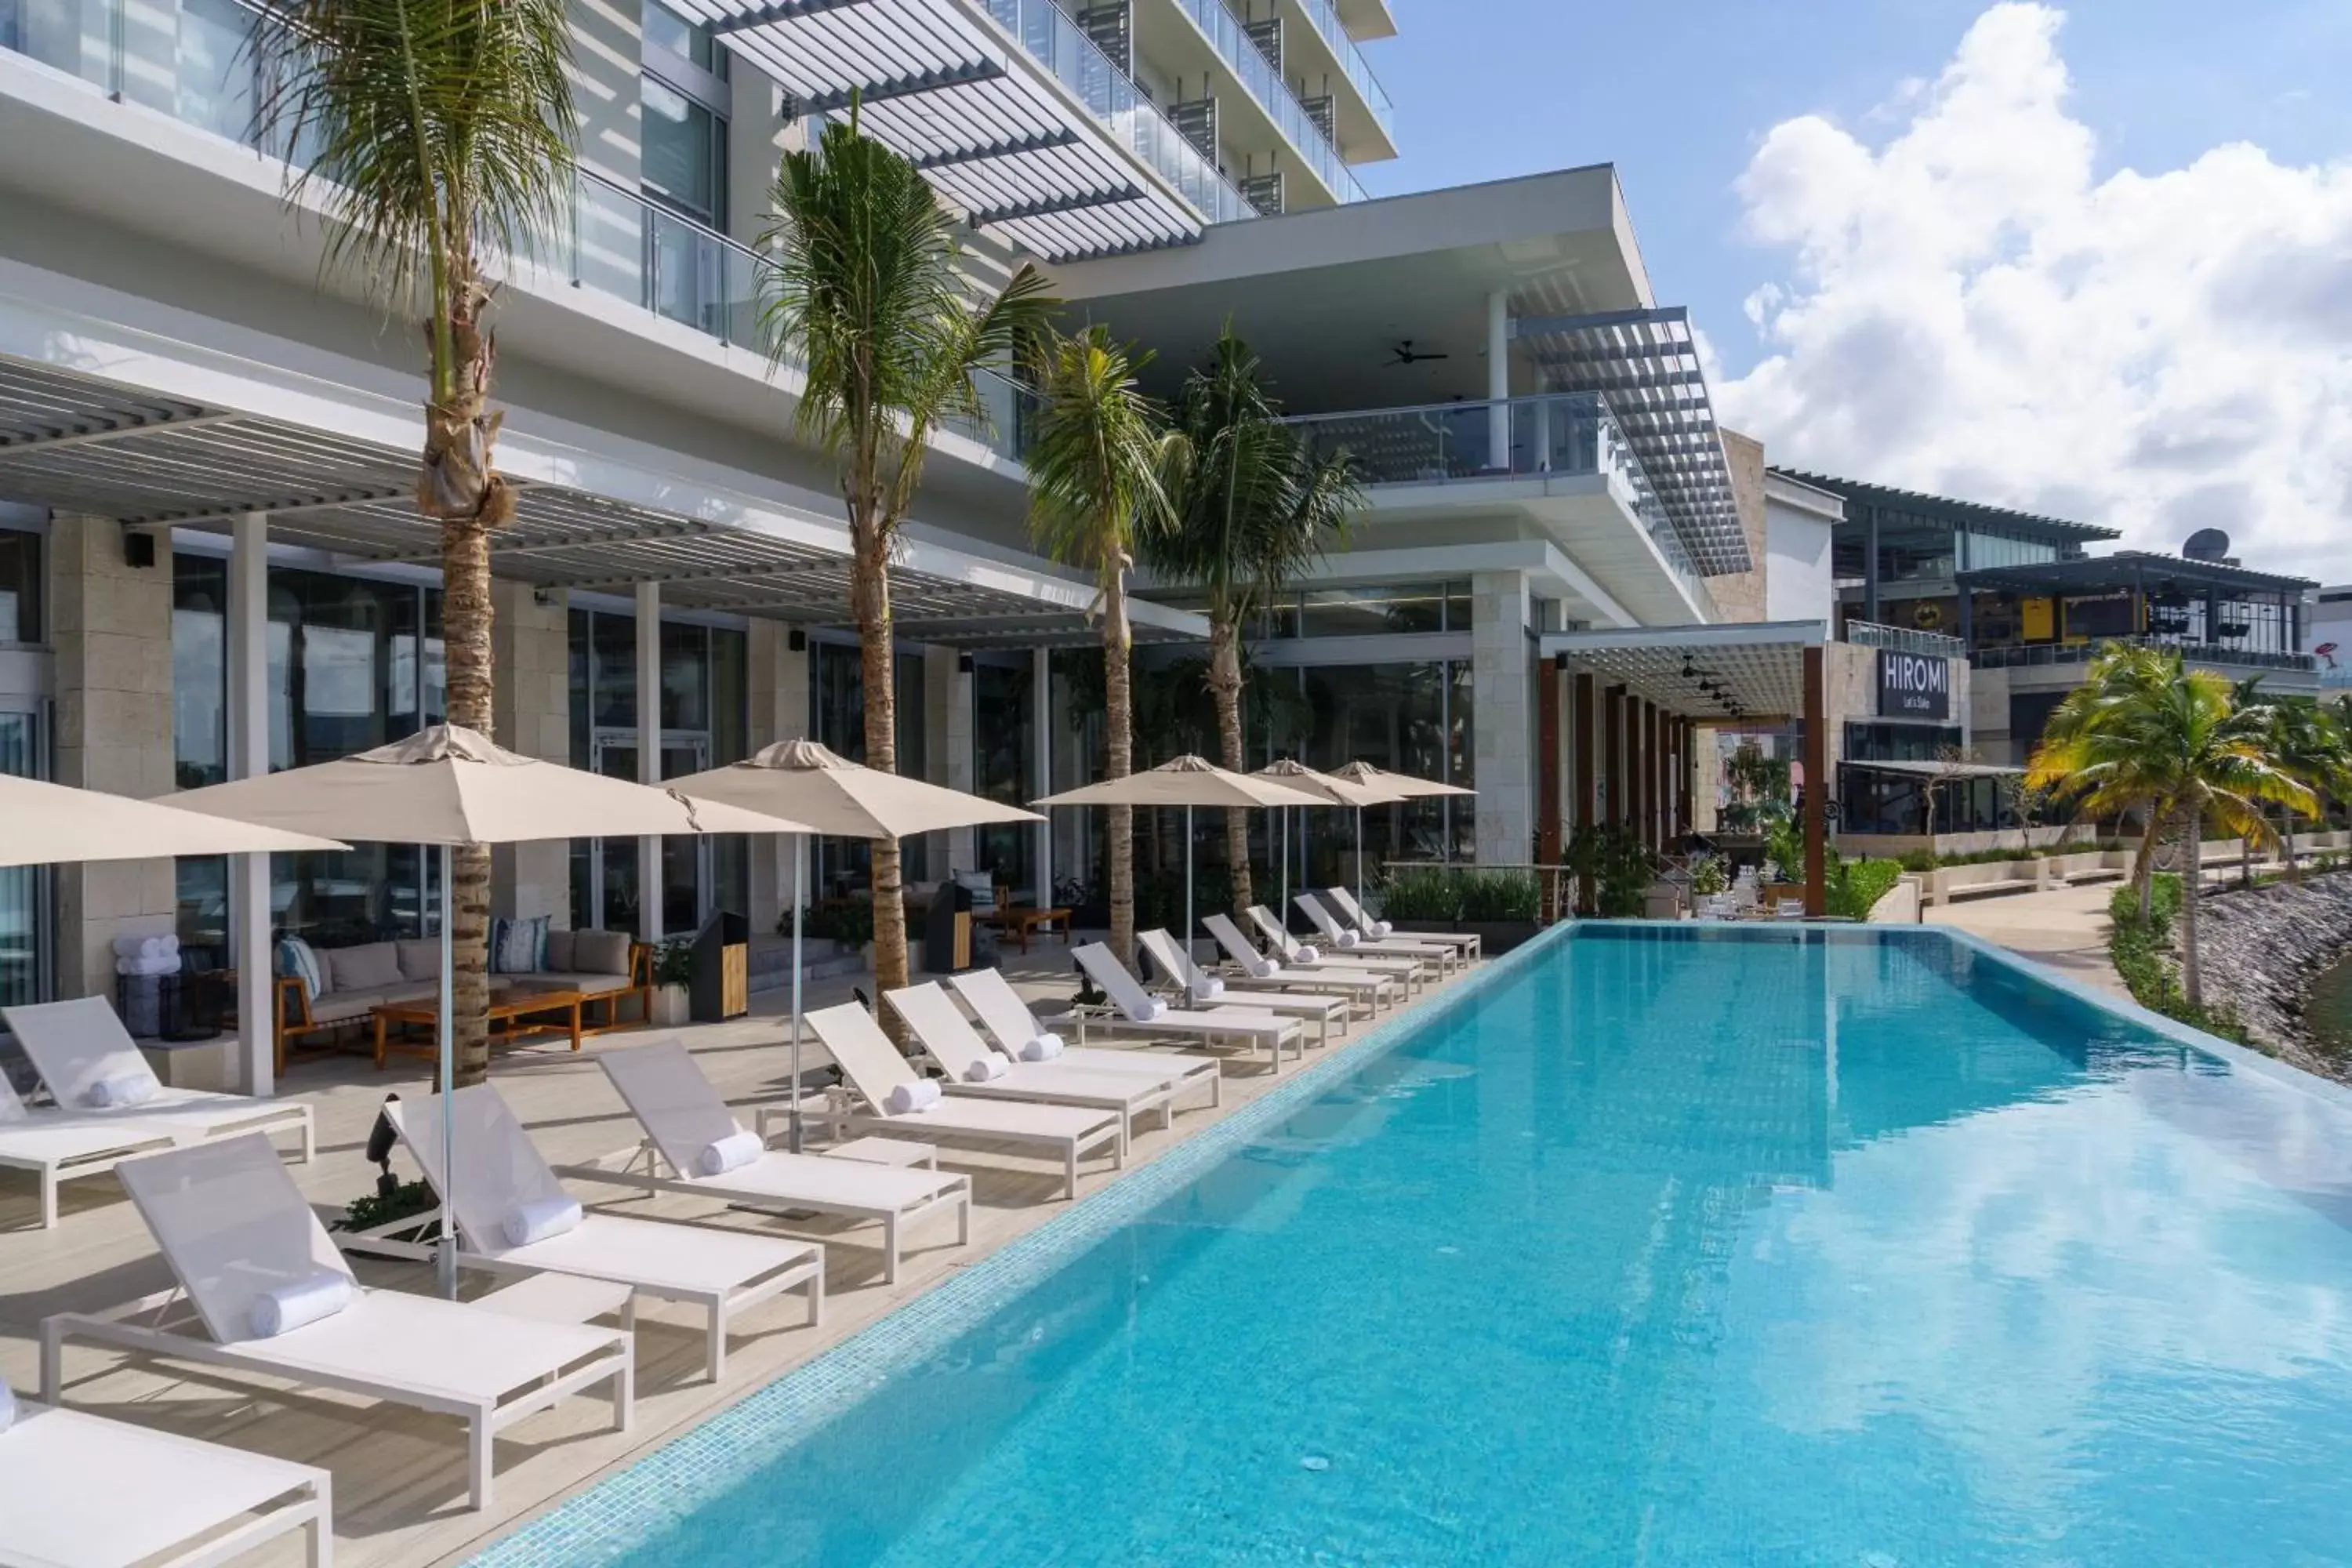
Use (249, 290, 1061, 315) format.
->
(2199, 872, 2352, 1081)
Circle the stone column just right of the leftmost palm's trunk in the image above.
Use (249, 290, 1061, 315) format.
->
(489, 579, 572, 926)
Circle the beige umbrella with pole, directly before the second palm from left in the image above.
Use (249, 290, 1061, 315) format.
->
(673, 741, 1044, 1154)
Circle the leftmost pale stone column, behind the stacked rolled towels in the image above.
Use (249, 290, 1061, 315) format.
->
(49, 513, 179, 1001)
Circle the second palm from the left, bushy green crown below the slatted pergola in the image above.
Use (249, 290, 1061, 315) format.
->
(760, 103, 1049, 1006)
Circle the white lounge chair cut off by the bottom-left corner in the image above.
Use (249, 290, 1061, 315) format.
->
(0, 1401, 334, 1568)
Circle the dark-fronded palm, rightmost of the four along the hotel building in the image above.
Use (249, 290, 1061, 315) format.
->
(1143, 327, 1364, 912)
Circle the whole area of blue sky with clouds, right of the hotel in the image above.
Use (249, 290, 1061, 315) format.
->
(1359, 0, 2352, 583)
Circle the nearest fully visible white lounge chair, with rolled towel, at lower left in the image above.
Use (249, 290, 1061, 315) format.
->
(40, 1133, 635, 1509)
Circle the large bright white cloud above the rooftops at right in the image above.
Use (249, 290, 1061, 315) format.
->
(1719, 2, 2352, 581)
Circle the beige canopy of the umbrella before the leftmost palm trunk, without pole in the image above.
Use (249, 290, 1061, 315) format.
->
(172, 724, 809, 846)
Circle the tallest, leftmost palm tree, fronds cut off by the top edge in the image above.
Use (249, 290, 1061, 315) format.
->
(252, 0, 574, 1083)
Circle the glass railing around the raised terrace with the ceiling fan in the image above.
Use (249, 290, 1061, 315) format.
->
(1287, 393, 1715, 619)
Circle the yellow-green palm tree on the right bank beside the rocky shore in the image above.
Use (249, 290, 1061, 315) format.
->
(2032, 654, 2314, 1006)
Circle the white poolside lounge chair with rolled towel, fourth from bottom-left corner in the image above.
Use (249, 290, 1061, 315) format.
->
(555, 1039, 971, 1283)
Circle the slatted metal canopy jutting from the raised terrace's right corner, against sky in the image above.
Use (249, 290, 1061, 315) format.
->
(1510, 306, 1755, 576)
